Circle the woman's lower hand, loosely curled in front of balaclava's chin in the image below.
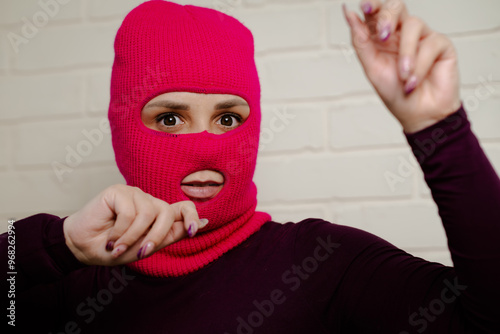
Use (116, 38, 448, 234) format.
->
(64, 185, 208, 265)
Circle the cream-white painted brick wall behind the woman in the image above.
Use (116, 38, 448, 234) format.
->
(0, 0, 500, 264)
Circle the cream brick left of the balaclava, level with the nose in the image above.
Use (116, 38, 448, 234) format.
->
(13, 118, 114, 170)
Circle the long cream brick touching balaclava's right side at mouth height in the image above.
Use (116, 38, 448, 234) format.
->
(255, 154, 413, 204)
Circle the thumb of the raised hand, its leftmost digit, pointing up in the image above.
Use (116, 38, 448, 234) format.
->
(342, 3, 377, 71)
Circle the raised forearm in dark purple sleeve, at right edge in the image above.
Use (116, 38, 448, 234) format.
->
(407, 109, 500, 323)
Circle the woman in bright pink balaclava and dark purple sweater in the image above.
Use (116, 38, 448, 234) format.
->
(2, 0, 500, 333)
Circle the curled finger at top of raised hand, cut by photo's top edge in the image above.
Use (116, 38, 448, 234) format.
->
(375, 0, 408, 41)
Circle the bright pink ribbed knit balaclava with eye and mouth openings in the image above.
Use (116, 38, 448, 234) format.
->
(109, 0, 271, 277)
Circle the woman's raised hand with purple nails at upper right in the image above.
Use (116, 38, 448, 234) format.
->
(343, 0, 461, 133)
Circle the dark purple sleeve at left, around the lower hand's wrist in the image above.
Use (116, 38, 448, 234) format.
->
(0, 214, 85, 292)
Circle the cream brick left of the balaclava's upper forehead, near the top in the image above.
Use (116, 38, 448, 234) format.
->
(14, 22, 119, 71)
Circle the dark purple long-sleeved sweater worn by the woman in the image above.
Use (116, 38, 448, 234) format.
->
(1, 109, 500, 334)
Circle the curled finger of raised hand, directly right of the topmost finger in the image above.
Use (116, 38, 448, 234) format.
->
(399, 16, 432, 81)
